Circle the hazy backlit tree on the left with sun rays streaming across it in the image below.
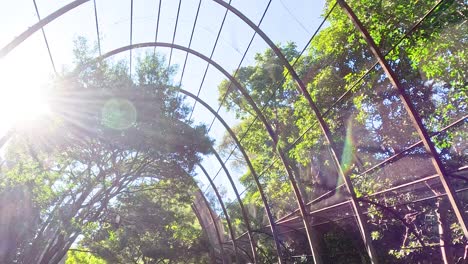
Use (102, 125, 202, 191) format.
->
(0, 39, 212, 263)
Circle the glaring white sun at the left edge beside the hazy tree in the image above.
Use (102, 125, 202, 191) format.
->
(0, 58, 50, 135)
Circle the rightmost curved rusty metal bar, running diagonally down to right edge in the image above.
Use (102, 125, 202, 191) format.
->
(338, 0, 468, 238)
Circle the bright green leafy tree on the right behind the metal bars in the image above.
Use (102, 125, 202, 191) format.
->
(219, 0, 468, 263)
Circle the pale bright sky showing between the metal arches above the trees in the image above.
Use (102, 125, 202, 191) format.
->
(0, 0, 324, 200)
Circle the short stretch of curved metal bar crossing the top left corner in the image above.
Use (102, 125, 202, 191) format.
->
(0, 0, 90, 59)
